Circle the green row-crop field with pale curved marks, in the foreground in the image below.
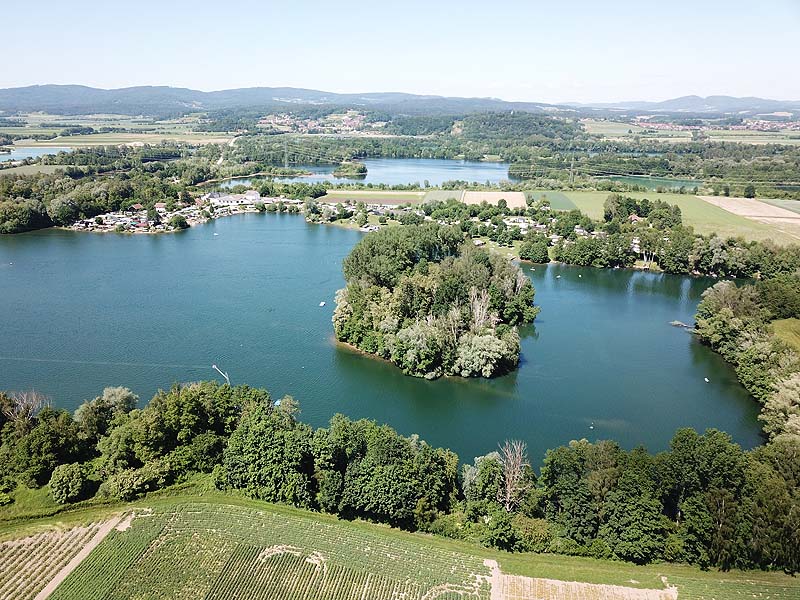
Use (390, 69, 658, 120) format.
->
(50, 504, 490, 600)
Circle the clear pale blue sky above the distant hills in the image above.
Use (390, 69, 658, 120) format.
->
(6, 0, 800, 102)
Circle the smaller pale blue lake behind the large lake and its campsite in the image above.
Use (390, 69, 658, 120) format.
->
(220, 158, 508, 187)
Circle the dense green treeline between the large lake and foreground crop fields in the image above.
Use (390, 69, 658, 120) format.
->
(0, 382, 800, 572)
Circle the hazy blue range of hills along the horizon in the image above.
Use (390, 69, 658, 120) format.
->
(0, 85, 800, 116)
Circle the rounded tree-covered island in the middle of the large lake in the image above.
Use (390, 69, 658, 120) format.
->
(333, 223, 539, 379)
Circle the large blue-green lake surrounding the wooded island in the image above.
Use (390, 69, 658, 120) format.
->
(0, 214, 760, 465)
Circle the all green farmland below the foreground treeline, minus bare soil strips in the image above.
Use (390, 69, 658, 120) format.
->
(0, 491, 800, 600)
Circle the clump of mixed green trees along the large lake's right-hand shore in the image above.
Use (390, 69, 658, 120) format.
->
(696, 278, 800, 440)
